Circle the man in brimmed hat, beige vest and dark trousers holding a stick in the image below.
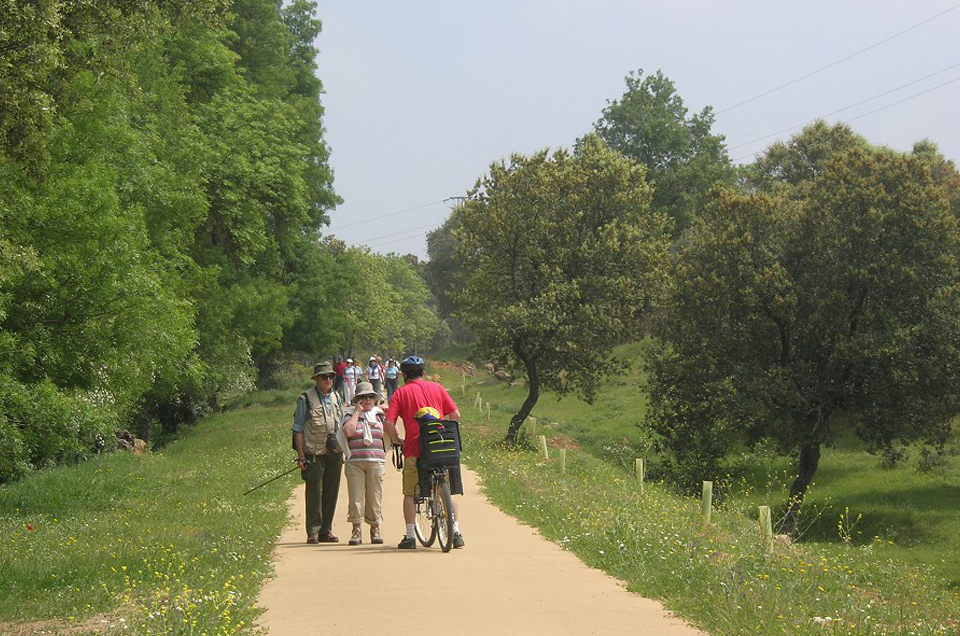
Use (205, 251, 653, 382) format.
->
(293, 362, 343, 543)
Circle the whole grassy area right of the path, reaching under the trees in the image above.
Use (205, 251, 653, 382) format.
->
(437, 352, 960, 636)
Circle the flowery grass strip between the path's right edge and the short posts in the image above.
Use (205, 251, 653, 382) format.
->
(456, 418, 960, 636)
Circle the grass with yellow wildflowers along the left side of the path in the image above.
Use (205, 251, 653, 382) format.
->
(0, 393, 296, 636)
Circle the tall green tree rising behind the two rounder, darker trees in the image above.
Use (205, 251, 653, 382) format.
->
(594, 70, 735, 235)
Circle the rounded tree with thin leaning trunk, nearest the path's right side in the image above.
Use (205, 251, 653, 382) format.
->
(454, 135, 670, 443)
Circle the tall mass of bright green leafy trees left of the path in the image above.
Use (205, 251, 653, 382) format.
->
(0, 0, 338, 472)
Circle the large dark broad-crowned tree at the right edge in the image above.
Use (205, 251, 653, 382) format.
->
(649, 135, 960, 525)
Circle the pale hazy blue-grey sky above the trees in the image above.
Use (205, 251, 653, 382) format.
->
(317, 0, 960, 258)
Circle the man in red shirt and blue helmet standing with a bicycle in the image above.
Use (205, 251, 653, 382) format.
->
(385, 356, 464, 550)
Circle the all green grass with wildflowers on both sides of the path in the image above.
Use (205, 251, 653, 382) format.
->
(7, 345, 960, 636)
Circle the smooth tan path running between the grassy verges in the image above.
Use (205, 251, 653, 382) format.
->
(260, 464, 704, 636)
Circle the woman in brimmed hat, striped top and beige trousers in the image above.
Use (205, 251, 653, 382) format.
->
(342, 382, 386, 545)
